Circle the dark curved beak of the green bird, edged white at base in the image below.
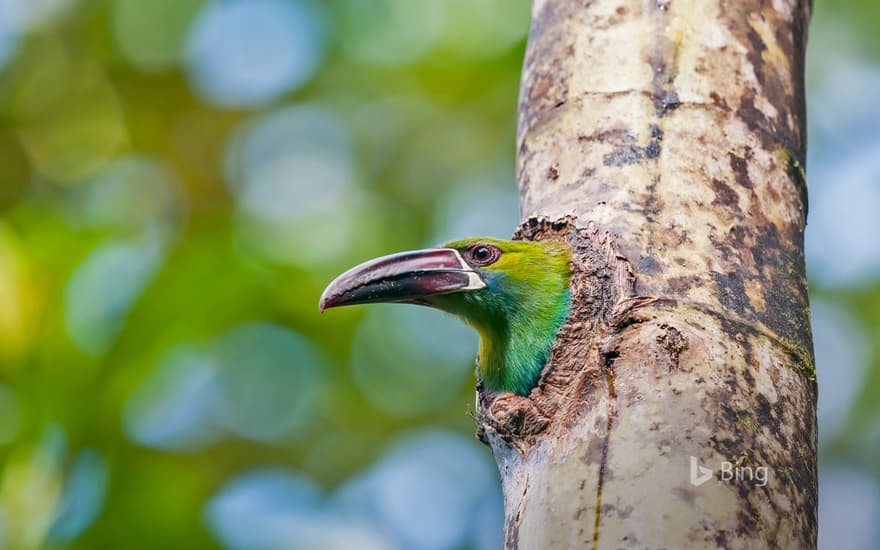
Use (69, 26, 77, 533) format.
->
(318, 248, 486, 313)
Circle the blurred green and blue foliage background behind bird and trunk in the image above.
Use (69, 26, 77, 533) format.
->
(0, 0, 880, 550)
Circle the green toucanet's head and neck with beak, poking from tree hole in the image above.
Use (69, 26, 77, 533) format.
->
(319, 237, 571, 395)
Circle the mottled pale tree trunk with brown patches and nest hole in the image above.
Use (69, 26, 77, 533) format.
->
(479, 0, 817, 550)
